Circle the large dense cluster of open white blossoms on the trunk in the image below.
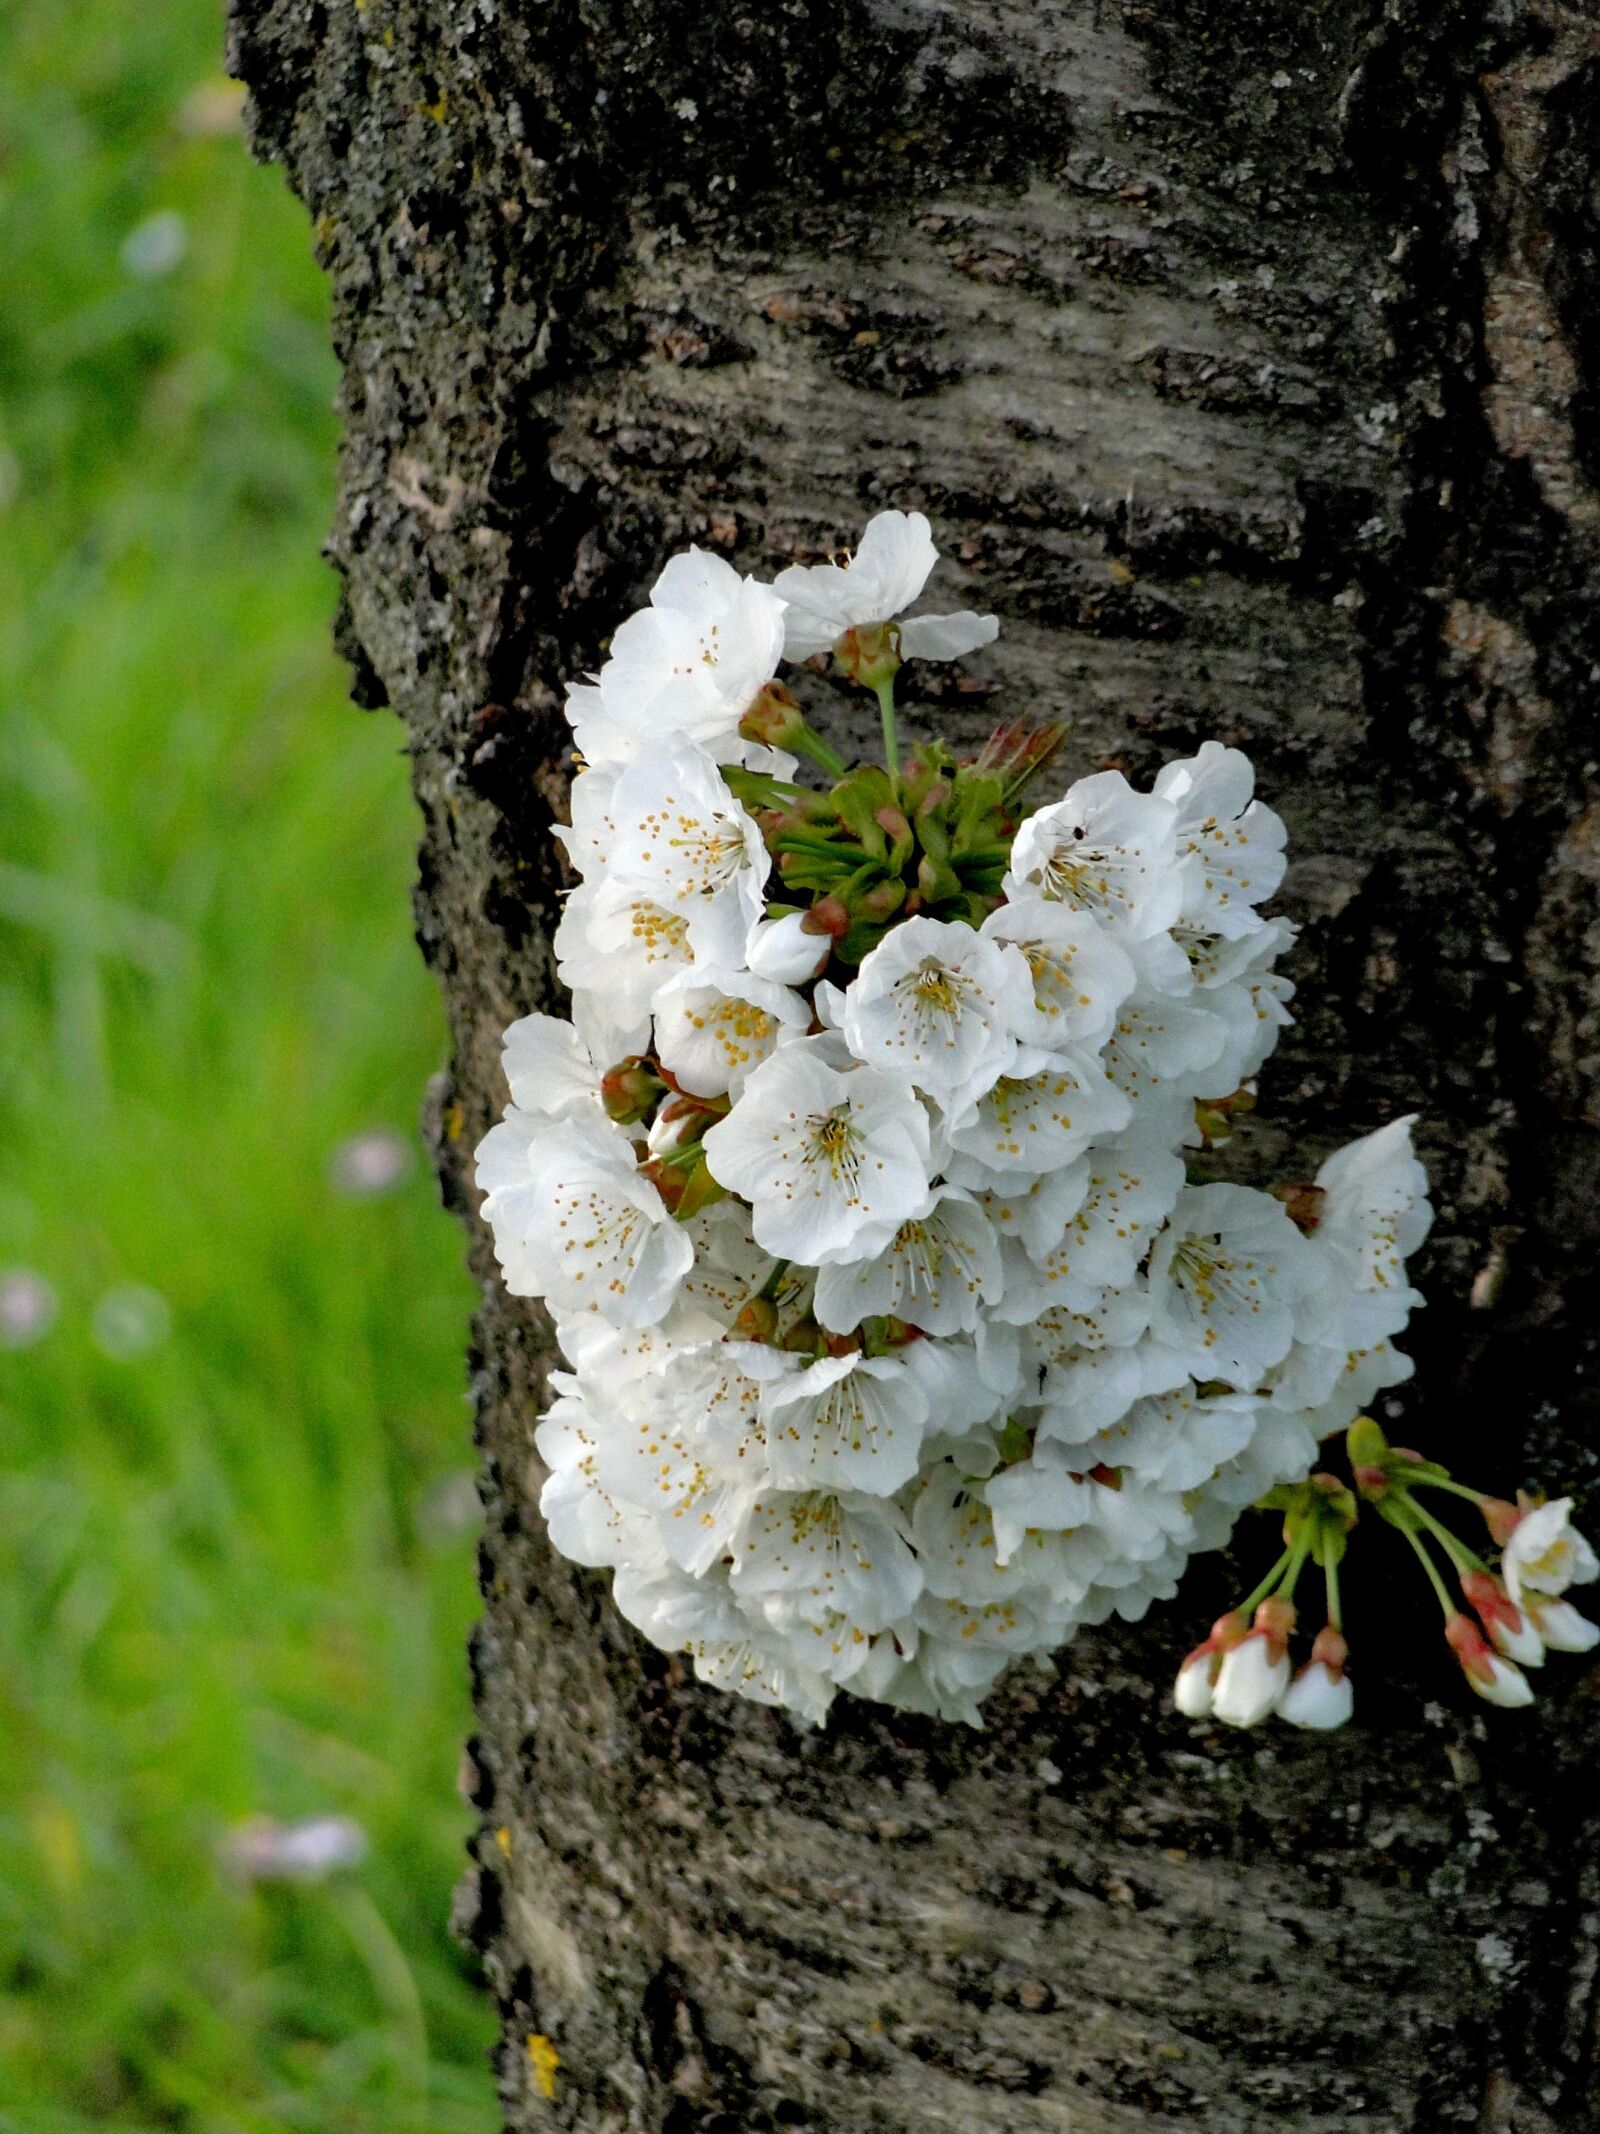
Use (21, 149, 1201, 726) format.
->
(478, 512, 1578, 1722)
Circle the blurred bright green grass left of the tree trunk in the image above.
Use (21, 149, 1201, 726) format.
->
(0, 0, 497, 2134)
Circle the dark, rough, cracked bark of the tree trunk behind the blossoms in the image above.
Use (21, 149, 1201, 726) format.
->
(233, 0, 1600, 2134)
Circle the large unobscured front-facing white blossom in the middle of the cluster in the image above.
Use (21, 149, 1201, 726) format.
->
(704, 1039, 928, 1268)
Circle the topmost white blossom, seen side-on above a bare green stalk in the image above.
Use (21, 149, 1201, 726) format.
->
(772, 512, 1001, 659)
